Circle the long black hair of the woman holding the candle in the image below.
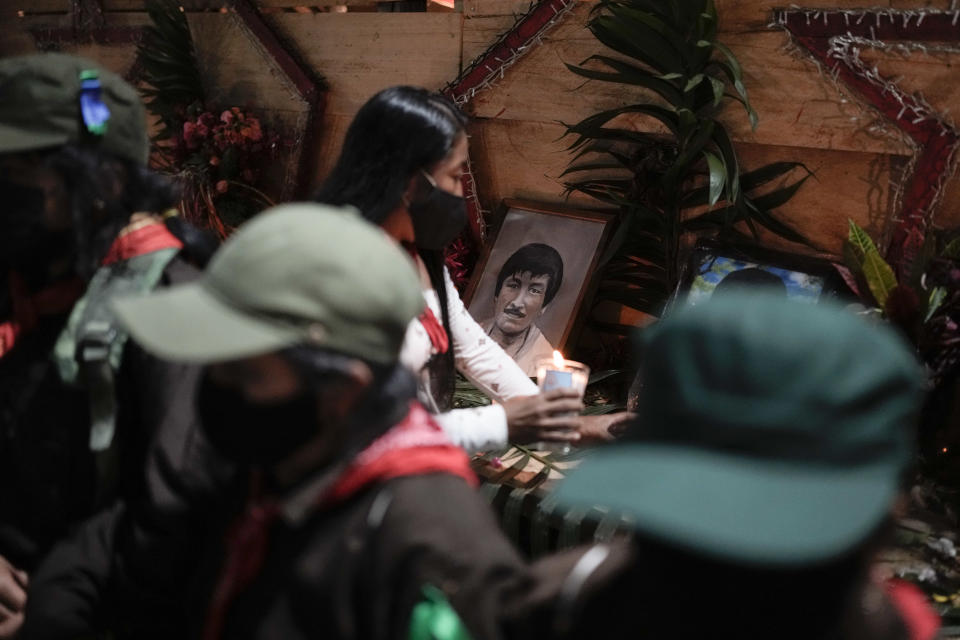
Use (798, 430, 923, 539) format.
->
(315, 86, 467, 410)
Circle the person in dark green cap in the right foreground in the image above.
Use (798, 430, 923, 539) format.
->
(506, 291, 939, 640)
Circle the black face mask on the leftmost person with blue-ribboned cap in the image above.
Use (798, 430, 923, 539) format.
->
(0, 178, 74, 284)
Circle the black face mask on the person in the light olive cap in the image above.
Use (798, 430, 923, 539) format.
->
(197, 376, 320, 467)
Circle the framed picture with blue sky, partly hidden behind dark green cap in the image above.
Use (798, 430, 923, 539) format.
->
(675, 239, 843, 305)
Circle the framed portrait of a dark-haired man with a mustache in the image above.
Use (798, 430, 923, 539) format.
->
(464, 200, 613, 375)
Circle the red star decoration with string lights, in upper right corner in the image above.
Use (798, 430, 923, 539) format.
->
(774, 9, 960, 268)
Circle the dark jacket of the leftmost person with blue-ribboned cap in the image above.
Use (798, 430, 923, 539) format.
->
(0, 258, 196, 571)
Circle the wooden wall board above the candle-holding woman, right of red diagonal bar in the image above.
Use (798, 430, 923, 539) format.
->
(272, 13, 462, 116)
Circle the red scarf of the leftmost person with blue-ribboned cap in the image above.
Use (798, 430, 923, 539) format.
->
(0, 222, 183, 358)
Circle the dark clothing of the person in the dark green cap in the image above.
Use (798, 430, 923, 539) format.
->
(503, 540, 935, 640)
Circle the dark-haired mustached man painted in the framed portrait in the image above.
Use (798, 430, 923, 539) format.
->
(483, 242, 563, 376)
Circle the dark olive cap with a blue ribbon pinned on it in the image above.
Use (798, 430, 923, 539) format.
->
(0, 53, 150, 164)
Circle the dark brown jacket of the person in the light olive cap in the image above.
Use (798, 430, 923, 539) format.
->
(21, 398, 529, 640)
